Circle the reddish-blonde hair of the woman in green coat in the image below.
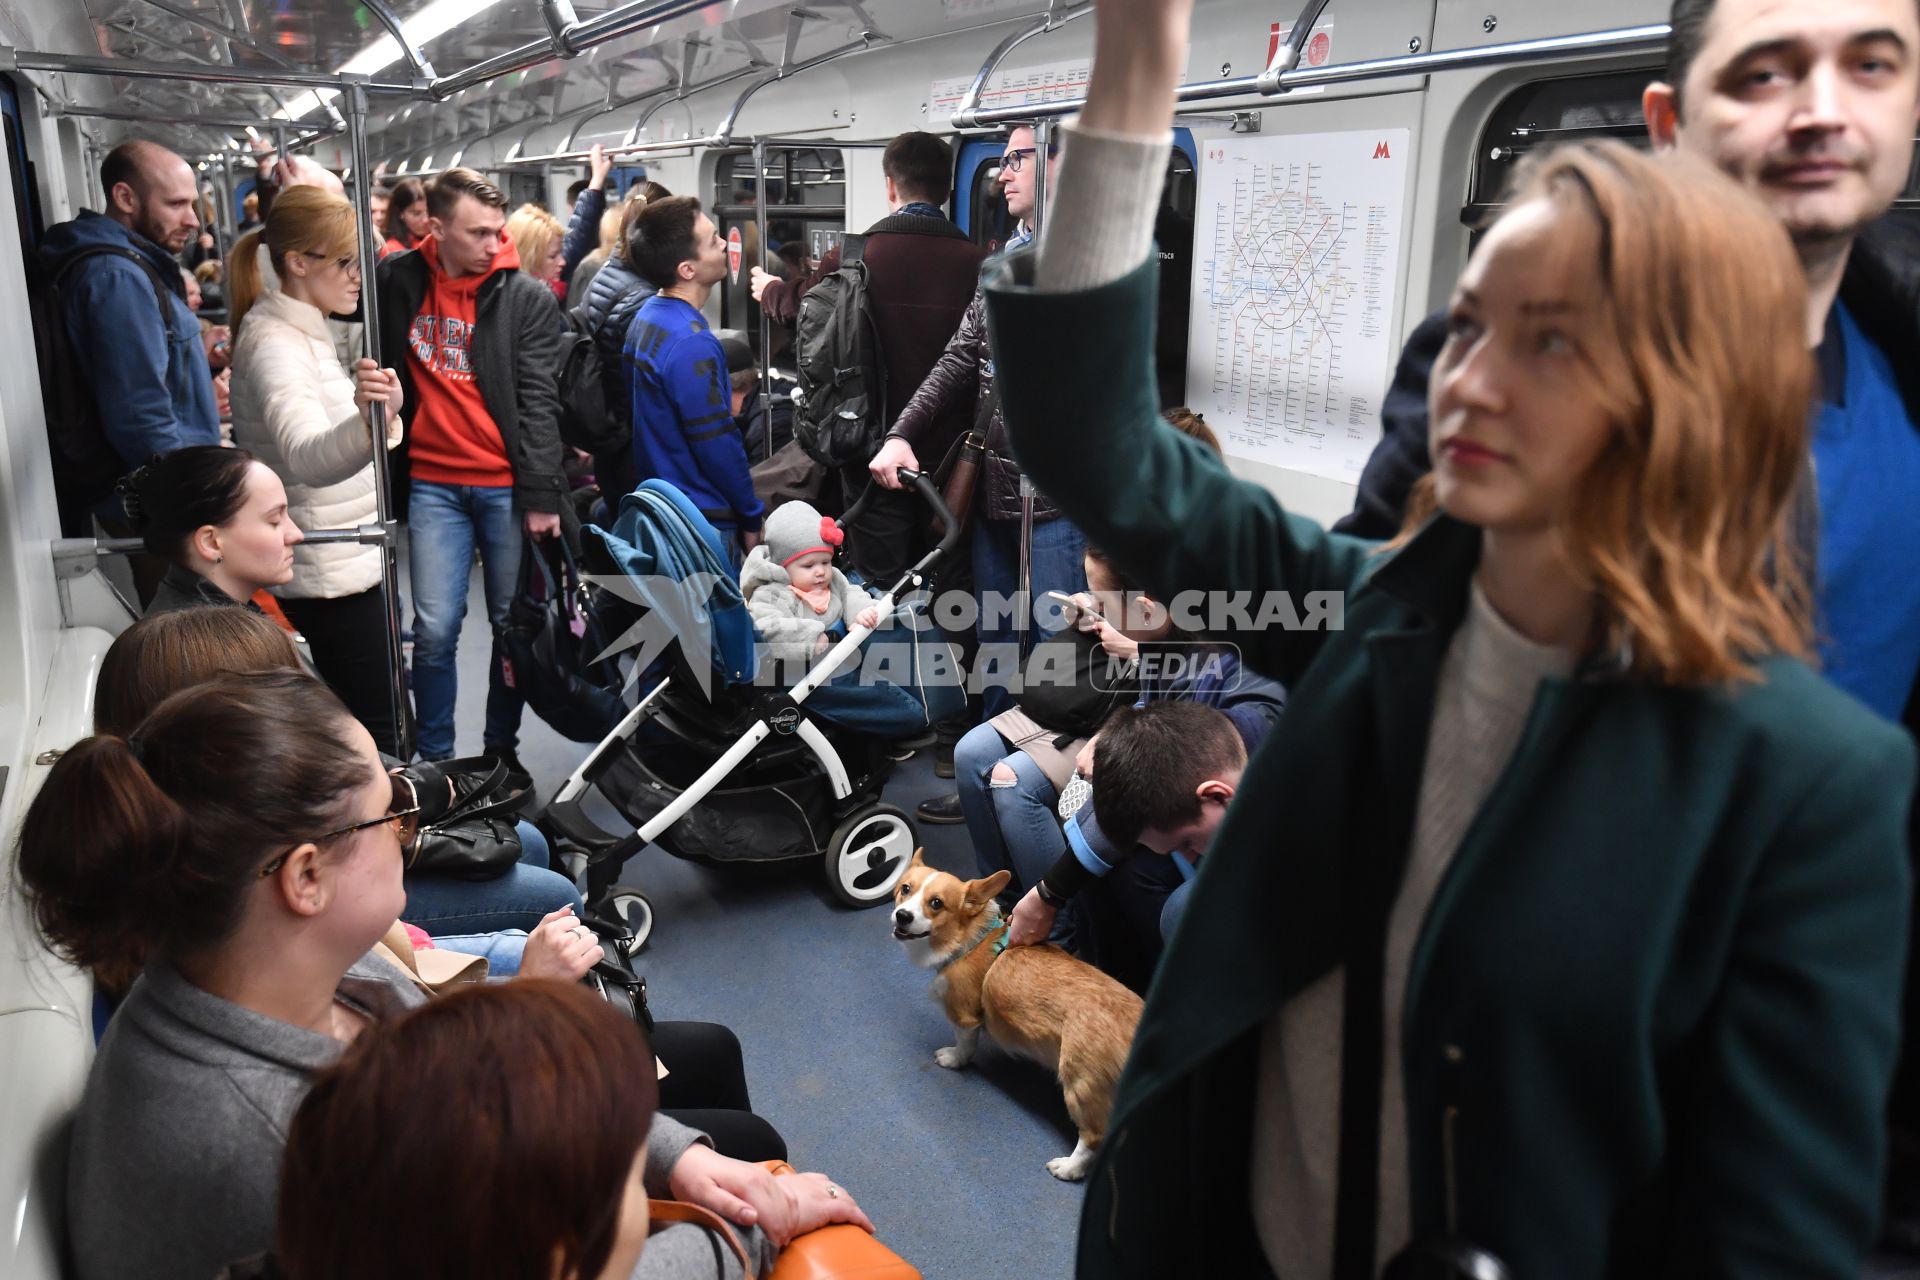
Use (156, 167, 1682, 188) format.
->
(1402, 142, 1814, 685)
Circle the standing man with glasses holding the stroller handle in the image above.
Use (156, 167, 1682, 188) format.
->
(868, 125, 1087, 823)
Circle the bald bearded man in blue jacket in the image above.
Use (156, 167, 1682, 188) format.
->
(40, 142, 221, 491)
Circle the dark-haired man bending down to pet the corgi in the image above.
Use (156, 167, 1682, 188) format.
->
(1006, 702, 1246, 969)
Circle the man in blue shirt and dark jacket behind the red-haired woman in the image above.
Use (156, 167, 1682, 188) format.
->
(1334, 0, 1920, 1255)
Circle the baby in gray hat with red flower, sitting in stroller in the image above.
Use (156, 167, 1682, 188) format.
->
(739, 501, 879, 664)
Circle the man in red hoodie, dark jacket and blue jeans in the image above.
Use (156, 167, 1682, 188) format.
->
(380, 169, 566, 787)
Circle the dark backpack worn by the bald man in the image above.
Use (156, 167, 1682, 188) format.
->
(27, 244, 173, 537)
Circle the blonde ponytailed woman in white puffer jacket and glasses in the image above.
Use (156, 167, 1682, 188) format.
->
(230, 186, 412, 754)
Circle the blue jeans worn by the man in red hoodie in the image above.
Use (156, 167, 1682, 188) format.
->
(407, 480, 526, 760)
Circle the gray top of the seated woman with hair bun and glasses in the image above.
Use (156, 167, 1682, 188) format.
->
(67, 956, 774, 1280)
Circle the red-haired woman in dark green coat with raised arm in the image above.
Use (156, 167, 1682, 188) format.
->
(987, 0, 1914, 1280)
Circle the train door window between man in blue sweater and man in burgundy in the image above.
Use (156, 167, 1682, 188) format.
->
(708, 148, 847, 370)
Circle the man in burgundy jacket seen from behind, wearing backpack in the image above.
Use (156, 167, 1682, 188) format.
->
(751, 132, 985, 585)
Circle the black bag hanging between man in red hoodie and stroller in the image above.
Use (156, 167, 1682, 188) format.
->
(499, 537, 626, 743)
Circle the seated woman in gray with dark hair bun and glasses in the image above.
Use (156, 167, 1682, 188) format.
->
(19, 672, 870, 1280)
